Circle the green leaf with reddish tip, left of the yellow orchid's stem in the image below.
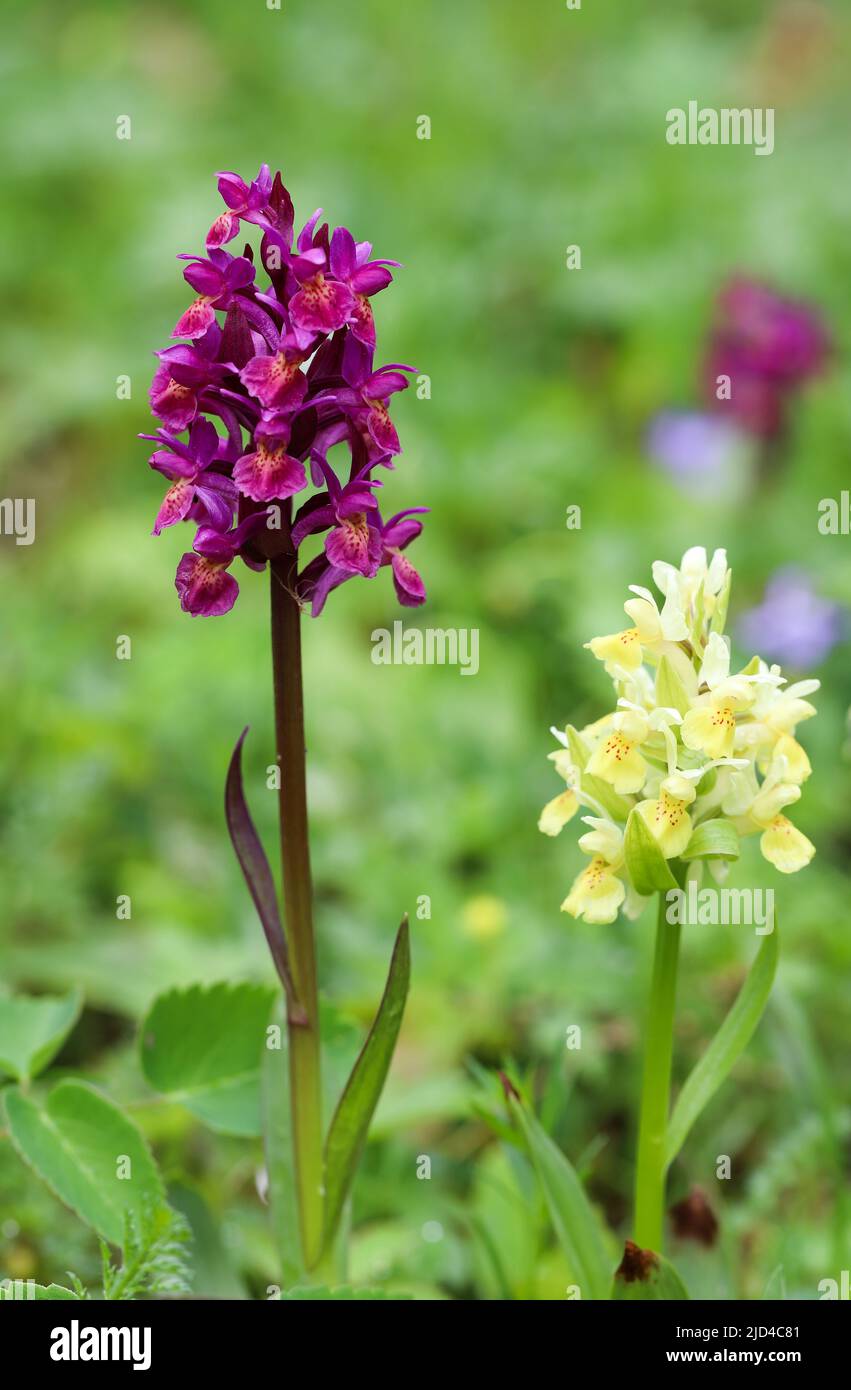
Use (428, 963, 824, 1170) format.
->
(508, 1097, 612, 1298)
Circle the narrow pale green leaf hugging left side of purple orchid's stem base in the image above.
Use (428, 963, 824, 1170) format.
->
(261, 999, 305, 1284)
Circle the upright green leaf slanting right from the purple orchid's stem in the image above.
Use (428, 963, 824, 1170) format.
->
(324, 917, 410, 1248)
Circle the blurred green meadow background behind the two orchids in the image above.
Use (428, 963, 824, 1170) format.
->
(0, 0, 851, 1298)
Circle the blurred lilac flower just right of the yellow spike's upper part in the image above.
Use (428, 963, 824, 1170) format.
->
(737, 569, 844, 670)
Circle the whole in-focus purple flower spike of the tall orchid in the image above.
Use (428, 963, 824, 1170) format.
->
(142, 164, 428, 616)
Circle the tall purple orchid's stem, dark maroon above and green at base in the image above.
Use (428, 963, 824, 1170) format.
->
(270, 553, 323, 1269)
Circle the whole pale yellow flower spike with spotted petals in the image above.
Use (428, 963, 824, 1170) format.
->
(538, 546, 819, 923)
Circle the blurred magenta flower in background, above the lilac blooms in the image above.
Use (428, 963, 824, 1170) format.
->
(705, 278, 830, 439)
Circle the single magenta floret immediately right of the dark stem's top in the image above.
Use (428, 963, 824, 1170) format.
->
(292, 459, 382, 578)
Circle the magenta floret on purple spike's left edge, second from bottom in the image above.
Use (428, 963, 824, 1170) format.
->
(139, 417, 239, 535)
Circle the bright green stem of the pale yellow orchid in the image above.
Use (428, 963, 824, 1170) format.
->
(635, 892, 680, 1251)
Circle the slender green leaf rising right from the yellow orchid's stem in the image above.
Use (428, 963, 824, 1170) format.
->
(665, 919, 779, 1165)
